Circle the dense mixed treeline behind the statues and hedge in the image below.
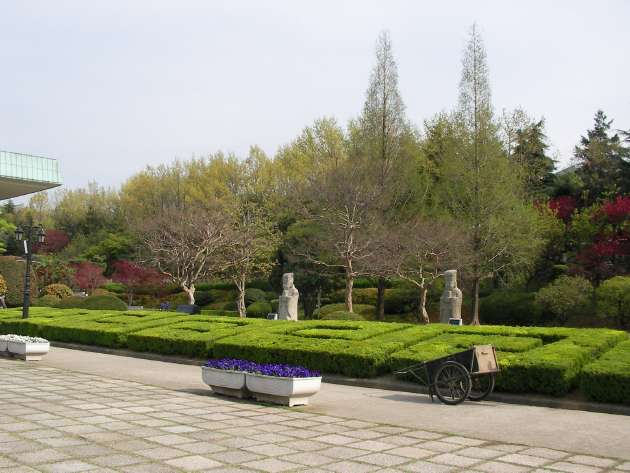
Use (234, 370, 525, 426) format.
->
(0, 27, 630, 325)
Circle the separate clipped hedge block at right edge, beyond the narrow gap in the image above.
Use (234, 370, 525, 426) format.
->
(580, 340, 630, 404)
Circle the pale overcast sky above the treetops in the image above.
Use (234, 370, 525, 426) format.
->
(0, 0, 630, 192)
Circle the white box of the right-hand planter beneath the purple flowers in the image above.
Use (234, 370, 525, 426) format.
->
(245, 373, 322, 407)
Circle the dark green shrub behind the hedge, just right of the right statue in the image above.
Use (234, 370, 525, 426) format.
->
(479, 291, 541, 325)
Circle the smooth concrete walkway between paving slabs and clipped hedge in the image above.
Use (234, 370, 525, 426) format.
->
(40, 347, 630, 460)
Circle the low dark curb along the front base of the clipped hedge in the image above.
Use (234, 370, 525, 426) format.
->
(50, 342, 630, 416)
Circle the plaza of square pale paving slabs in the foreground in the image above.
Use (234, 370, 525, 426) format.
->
(0, 351, 630, 473)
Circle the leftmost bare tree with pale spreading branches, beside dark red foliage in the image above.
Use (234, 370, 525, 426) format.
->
(142, 208, 229, 304)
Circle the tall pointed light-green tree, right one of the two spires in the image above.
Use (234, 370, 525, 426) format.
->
(439, 25, 543, 325)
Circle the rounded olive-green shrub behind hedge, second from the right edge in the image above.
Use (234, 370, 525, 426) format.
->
(536, 276, 593, 324)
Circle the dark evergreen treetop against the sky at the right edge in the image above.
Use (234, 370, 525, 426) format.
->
(574, 110, 630, 205)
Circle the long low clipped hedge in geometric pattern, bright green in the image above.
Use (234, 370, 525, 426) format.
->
(0, 307, 630, 402)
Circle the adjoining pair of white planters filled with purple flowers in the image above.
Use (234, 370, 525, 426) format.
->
(202, 358, 322, 406)
